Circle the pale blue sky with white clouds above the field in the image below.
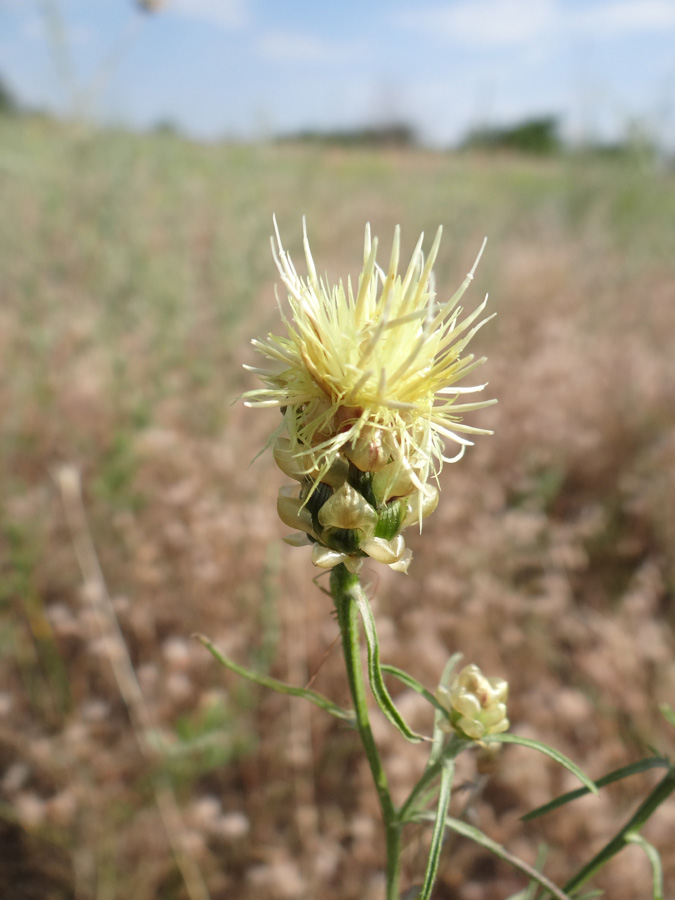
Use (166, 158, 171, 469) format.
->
(0, 0, 675, 146)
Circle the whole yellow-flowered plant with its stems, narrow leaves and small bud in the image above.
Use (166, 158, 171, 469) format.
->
(204, 222, 672, 900)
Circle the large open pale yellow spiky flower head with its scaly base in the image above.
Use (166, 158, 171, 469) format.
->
(244, 221, 494, 572)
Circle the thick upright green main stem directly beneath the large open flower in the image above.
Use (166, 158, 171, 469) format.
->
(330, 564, 401, 900)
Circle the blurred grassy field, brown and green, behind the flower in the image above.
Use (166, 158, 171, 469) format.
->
(0, 119, 675, 900)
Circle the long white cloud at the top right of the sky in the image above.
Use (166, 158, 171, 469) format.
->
(398, 0, 675, 47)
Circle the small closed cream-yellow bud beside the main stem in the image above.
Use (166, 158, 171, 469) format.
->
(436, 664, 510, 741)
